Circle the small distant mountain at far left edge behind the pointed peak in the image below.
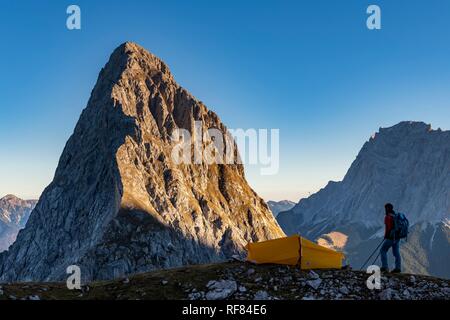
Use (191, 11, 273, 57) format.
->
(0, 194, 37, 252)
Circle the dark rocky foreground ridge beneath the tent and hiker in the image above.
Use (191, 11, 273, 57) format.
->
(0, 261, 450, 300)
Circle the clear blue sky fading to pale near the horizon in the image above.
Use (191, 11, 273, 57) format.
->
(0, 0, 450, 201)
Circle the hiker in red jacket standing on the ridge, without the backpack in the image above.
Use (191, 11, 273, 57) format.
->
(380, 203, 402, 273)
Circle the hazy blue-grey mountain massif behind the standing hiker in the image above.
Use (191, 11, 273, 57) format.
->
(277, 122, 450, 278)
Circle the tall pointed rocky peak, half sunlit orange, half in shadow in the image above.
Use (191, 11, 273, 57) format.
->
(0, 42, 284, 281)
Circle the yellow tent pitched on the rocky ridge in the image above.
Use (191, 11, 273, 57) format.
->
(246, 235, 344, 269)
